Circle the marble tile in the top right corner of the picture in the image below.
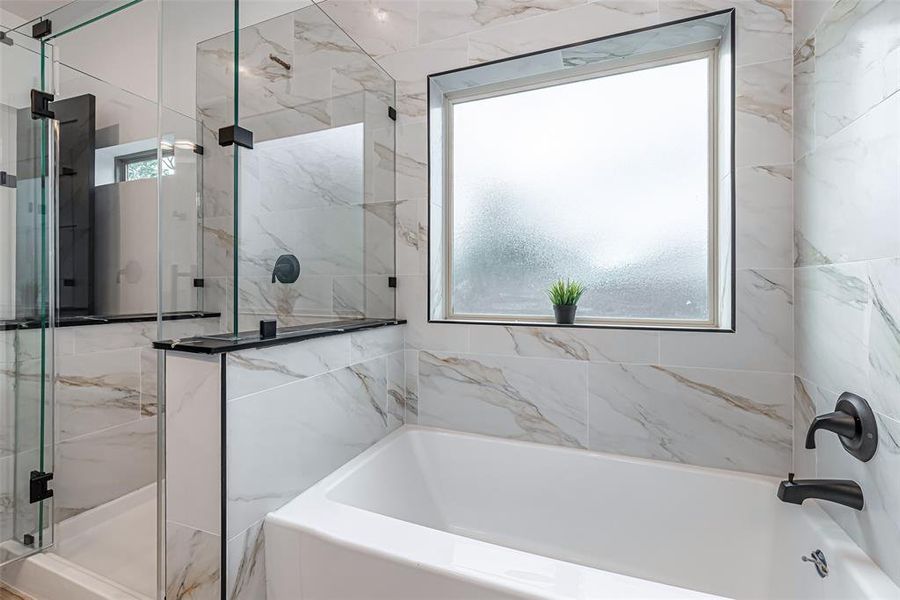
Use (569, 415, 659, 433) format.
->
(815, 0, 900, 139)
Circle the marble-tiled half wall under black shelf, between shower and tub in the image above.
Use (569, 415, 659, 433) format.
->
(166, 326, 406, 600)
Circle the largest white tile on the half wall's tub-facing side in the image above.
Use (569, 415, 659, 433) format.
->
(227, 358, 388, 537)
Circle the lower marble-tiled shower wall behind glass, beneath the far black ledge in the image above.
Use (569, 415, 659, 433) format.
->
(53, 319, 218, 522)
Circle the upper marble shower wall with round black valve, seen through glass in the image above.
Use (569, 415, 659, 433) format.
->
(197, 6, 395, 329)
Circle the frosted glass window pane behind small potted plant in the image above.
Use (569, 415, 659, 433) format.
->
(445, 56, 715, 323)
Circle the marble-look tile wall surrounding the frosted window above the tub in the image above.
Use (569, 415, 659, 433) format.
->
(319, 0, 794, 475)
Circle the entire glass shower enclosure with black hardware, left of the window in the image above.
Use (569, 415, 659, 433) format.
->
(0, 0, 396, 598)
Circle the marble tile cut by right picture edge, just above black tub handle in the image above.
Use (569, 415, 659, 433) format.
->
(868, 258, 900, 419)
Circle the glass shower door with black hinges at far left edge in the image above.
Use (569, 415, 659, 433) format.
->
(0, 31, 53, 563)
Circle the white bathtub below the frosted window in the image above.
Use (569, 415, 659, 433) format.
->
(265, 426, 900, 600)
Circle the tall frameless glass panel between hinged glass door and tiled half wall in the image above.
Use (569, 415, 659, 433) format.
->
(29, 0, 159, 597)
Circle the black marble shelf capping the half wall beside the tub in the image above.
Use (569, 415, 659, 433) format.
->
(153, 319, 406, 354)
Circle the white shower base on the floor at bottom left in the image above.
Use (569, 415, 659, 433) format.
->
(4, 484, 156, 600)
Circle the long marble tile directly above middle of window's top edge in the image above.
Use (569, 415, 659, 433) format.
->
(469, 0, 659, 63)
